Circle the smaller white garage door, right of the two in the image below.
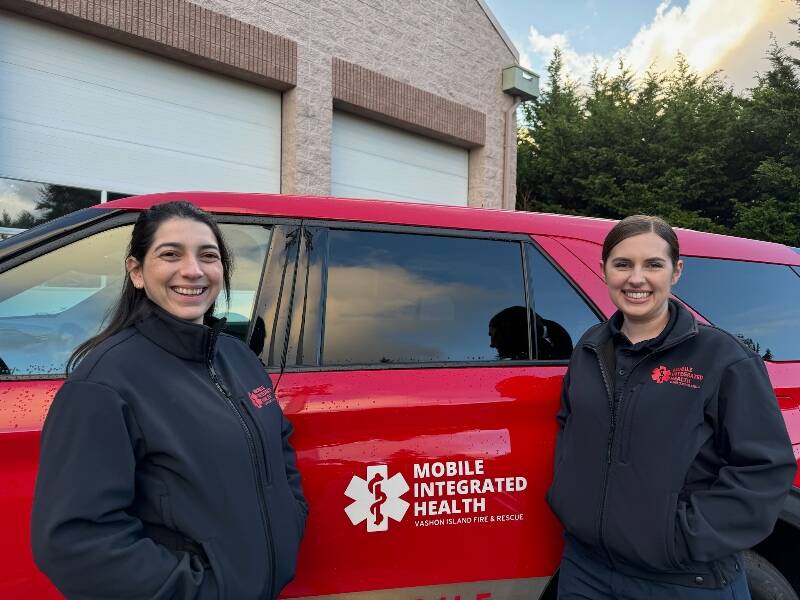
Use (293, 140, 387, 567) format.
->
(331, 112, 469, 206)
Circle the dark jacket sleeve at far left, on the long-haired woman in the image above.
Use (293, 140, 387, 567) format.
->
(31, 381, 218, 600)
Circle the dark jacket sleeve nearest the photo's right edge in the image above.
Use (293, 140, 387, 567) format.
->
(676, 356, 797, 561)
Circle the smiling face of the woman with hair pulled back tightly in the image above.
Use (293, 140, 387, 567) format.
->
(601, 232, 683, 323)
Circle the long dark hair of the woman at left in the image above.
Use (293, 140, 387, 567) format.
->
(66, 201, 233, 373)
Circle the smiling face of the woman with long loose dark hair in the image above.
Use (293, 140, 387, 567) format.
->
(126, 218, 223, 323)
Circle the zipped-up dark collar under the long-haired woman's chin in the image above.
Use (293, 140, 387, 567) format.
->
(134, 302, 225, 362)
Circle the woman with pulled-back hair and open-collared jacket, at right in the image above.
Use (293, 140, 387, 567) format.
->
(548, 215, 796, 600)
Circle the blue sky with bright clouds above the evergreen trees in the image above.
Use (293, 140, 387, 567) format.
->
(486, 0, 800, 92)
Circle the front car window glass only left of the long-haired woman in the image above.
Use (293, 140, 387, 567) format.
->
(0, 225, 132, 375)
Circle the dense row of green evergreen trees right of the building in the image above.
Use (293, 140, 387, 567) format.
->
(517, 0, 800, 246)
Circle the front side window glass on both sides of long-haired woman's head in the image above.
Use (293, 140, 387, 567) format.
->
(0, 224, 270, 375)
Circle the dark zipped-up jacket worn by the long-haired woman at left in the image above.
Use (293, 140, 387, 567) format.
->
(31, 306, 307, 600)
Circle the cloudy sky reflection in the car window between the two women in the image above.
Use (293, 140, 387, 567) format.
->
(322, 230, 528, 365)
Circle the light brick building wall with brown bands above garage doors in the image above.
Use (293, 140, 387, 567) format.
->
(0, 0, 516, 208)
